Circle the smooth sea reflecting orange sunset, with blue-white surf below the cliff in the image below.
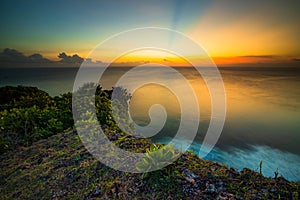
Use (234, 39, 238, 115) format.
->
(0, 67, 300, 181)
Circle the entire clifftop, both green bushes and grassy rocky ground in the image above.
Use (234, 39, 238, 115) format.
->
(0, 86, 300, 199)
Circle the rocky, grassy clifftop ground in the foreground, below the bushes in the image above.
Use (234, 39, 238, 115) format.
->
(0, 130, 300, 199)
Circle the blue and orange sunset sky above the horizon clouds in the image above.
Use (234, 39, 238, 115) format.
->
(0, 0, 300, 64)
